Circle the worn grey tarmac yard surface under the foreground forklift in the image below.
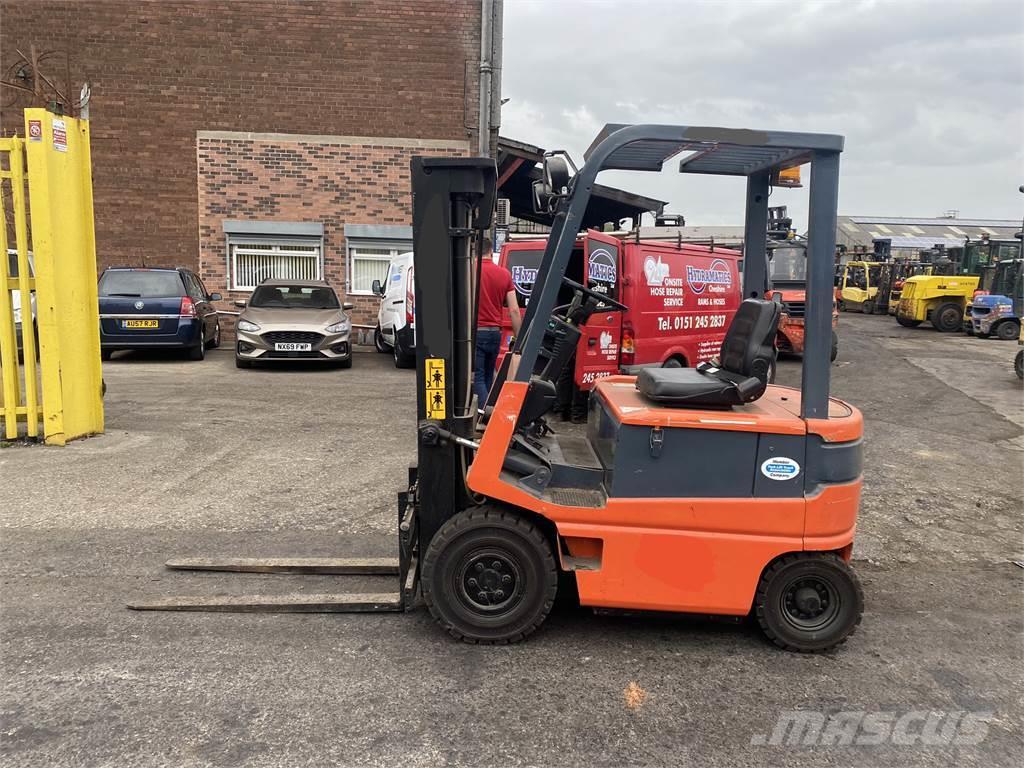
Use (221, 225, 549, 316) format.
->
(0, 314, 1024, 768)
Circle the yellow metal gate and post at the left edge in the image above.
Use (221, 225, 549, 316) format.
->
(0, 109, 103, 445)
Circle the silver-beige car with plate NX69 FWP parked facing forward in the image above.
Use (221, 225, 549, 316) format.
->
(234, 280, 352, 368)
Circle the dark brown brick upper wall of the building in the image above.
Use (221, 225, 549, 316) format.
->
(0, 0, 480, 268)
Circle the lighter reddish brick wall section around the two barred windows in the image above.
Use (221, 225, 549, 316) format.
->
(197, 132, 469, 331)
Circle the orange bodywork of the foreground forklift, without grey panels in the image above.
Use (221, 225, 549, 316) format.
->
(468, 376, 862, 615)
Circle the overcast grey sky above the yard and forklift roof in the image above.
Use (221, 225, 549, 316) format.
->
(501, 0, 1024, 226)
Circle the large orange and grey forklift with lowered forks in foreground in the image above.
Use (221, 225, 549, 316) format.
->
(130, 125, 863, 652)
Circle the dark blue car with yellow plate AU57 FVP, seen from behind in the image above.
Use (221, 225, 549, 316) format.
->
(98, 267, 221, 360)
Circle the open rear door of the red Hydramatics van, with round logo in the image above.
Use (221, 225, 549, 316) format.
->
(575, 229, 623, 390)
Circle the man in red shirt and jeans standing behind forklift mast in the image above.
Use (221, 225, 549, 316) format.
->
(473, 238, 522, 408)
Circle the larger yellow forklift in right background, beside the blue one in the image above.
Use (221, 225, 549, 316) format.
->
(896, 236, 1020, 333)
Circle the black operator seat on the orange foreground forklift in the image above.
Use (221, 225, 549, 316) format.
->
(636, 299, 779, 408)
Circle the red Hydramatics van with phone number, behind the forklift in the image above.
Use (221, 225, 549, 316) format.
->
(499, 230, 741, 391)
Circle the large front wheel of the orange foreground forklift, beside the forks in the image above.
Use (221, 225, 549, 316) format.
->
(420, 507, 558, 645)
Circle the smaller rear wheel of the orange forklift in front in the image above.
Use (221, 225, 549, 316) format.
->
(754, 553, 864, 653)
